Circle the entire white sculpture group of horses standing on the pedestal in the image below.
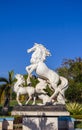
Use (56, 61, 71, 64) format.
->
(14, 43, 68, 105)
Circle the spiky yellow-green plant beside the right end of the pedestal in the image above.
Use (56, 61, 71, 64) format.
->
(66, 102, 82, 115)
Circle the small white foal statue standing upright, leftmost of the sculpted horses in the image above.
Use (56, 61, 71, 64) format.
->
(13, 74, 35, 106)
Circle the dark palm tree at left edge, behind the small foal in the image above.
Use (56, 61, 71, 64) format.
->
(0, 71, 15, 108)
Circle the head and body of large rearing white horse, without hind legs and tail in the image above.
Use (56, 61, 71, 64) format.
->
(26, 43, 59, 90)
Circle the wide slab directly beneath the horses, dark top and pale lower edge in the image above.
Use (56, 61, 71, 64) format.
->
(11, 105, 69, 117)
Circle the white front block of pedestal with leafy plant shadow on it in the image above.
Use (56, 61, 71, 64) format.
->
(23, 117, 58, 130)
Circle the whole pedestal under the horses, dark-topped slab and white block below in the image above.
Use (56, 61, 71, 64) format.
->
(12, 105, 73, 130)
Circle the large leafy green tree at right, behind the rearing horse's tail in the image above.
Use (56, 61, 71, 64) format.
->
(57, 58, 82, 103)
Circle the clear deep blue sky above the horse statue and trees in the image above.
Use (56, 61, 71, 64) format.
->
(0, 0, 82, 76)
